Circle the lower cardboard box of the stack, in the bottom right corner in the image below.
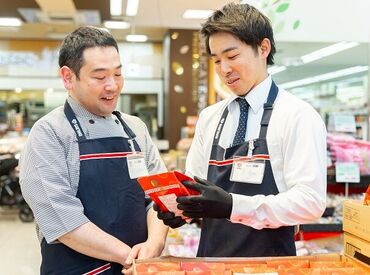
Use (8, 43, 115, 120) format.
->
(343, 232, 370, 266)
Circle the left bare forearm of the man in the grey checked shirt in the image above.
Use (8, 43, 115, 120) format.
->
(59, 222, 131, 264)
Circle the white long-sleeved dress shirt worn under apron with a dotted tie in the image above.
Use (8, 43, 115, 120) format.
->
(186, 76, 326, 229)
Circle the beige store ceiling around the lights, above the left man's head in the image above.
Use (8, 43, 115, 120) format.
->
(0, 0, 239, 41)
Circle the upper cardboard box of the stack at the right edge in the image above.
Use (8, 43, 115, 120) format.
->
(343, 200, 370, 242)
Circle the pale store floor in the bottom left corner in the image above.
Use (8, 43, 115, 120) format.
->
(0, 208, 41, 275)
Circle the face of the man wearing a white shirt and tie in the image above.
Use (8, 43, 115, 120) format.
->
(209, 32, 268, 96)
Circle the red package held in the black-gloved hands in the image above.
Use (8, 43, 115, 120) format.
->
(137, 171, 199, 216)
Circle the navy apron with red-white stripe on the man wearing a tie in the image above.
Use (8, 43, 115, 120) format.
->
(197, 82, 296, 257)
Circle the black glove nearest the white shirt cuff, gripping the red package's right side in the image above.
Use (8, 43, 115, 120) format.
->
(176, 177, 232, 219)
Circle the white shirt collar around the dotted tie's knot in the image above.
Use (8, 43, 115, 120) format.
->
(229, 75, 272, 113)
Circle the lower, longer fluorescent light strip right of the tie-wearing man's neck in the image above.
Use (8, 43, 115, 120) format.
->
(279, 66, 369, 89)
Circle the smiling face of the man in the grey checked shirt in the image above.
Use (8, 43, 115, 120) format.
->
(70, 47, 123, 116)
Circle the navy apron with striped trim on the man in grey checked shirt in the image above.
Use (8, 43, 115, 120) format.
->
(41, 102, 147, 275)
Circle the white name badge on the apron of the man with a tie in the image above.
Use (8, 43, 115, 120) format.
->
(230, 160, 265, 184)
